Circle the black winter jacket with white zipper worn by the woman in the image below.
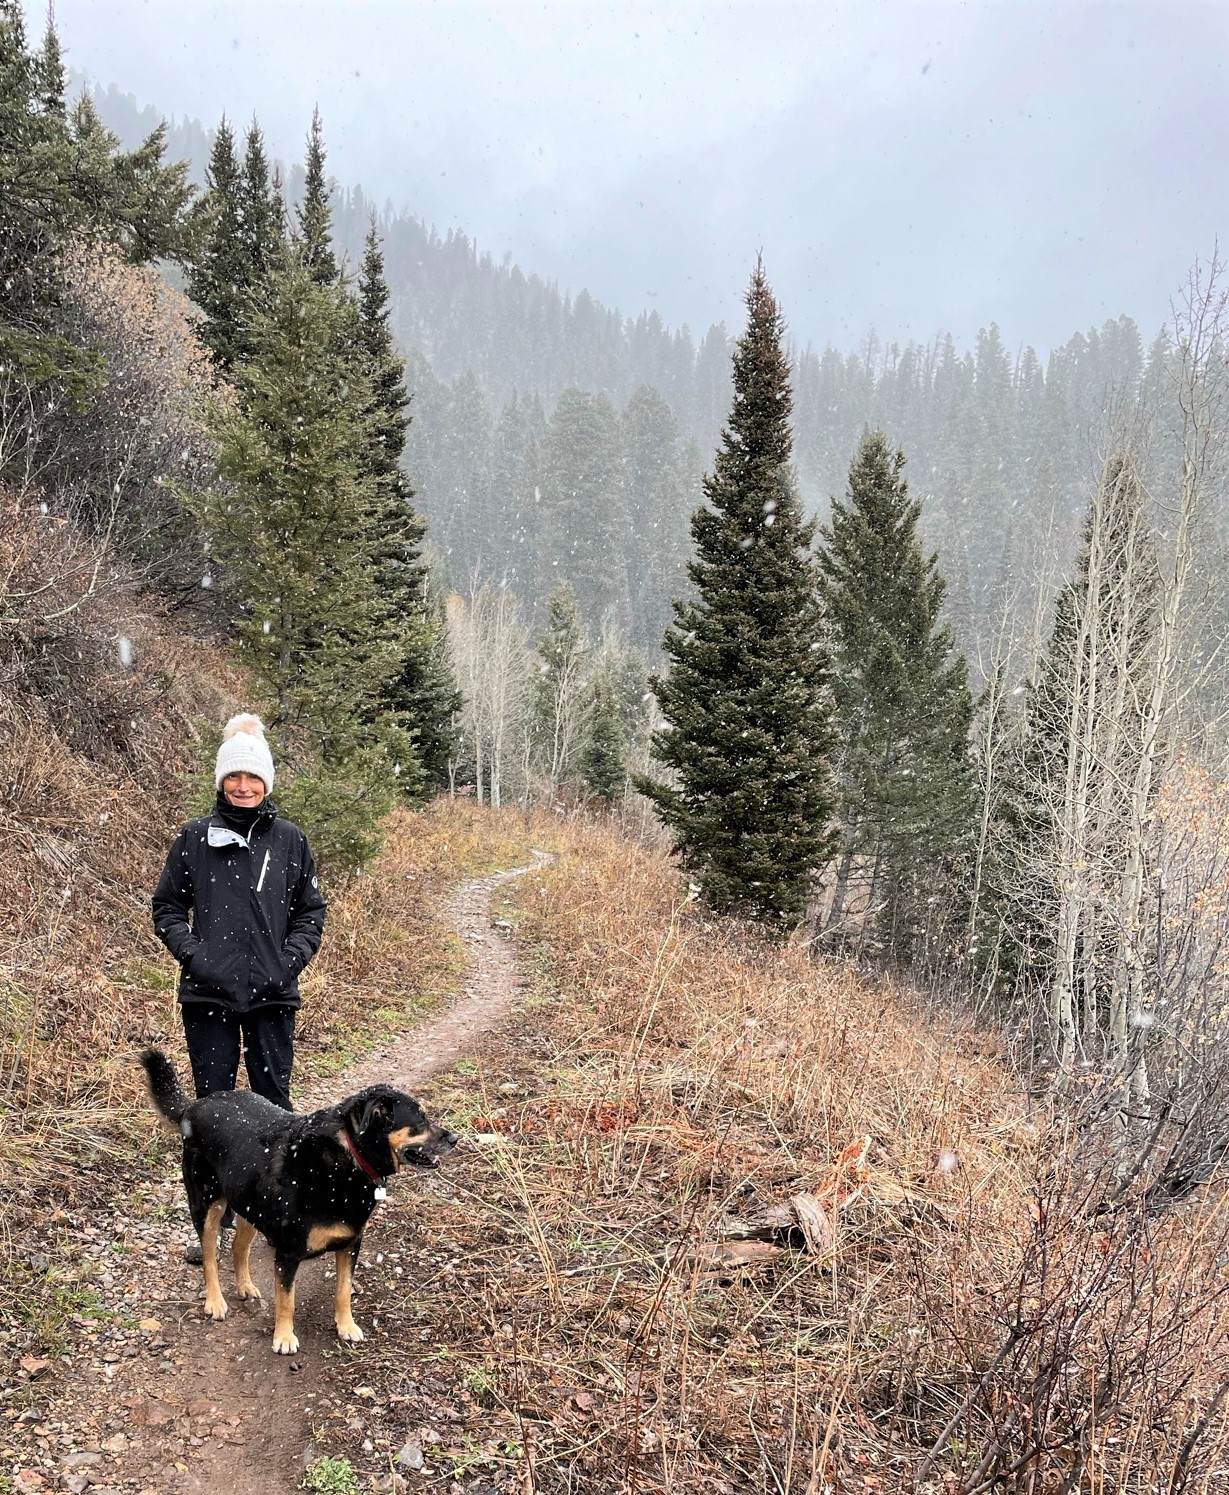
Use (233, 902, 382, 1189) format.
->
(154, 800, 327, 1012)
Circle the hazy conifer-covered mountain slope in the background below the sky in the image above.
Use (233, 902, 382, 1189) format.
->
(88, 81, 1220, 674)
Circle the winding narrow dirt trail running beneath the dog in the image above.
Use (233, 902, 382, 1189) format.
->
(24, 852, 549, 1495)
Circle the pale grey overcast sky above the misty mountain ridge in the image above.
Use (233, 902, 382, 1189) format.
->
(53, 0, 1229, 350)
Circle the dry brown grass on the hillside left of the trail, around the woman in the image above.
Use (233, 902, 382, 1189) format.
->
(0, 492, 547, 1184)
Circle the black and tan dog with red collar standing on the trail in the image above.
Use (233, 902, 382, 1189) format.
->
(141, 1048, 458, 1354)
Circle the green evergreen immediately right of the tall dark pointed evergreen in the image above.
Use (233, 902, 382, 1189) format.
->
(819, 432, 972, 958)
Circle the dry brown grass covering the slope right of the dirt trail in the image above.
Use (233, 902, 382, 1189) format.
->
(342, 825, 1229, 1495)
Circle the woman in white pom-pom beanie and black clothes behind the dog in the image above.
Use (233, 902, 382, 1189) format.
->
(154, 713, 326, 1111)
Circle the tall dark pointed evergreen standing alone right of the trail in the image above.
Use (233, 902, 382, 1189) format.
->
(637, 265, 833, 931)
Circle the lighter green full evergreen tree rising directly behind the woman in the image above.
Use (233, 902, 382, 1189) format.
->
(202, 254, 420, 869)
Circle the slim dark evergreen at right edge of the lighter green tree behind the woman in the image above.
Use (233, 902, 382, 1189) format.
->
(357, 223, 461, 786)
